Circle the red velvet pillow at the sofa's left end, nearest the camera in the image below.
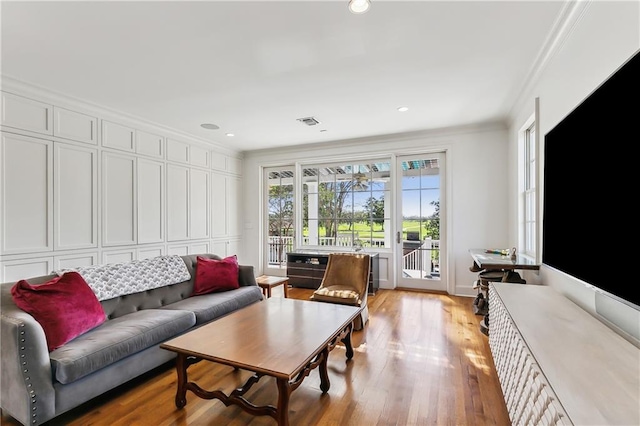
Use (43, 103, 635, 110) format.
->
(11, 272, 107, 352)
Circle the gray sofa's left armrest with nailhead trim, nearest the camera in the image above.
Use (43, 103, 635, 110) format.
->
(0, 302, 56, 425)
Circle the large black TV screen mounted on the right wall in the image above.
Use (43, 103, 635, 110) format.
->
(542, 51, 640, 309)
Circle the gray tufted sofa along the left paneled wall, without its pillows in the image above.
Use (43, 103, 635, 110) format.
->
(0, 254, 263, 425)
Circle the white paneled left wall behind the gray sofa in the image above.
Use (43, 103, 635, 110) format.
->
(0, 81, 243, 282)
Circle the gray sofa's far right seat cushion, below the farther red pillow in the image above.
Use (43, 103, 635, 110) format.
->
(162, 286, 263, 324)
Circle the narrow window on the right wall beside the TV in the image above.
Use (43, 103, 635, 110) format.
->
(520, 109, 538, 258)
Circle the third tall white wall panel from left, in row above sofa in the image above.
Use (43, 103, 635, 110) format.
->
(102, 152, 136, 246)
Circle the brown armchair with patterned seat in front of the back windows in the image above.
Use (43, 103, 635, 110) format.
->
(310, 253, 371, 330)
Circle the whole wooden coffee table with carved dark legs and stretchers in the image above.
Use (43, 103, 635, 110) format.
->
(160, 297, 362, 425)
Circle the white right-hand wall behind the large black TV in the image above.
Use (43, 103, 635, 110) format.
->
(509, 1, 640, 339)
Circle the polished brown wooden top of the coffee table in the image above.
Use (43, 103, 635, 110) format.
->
(160, 297, 361, 380)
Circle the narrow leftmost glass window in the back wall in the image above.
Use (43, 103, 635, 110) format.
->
(265, 166, 295, 268)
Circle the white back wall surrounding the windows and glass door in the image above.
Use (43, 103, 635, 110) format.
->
(243, 123, 508, 296)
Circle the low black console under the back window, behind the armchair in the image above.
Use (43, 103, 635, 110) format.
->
(287, 251, 380, 295)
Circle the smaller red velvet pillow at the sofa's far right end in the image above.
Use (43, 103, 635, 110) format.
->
(192, 255, 240, 296)
